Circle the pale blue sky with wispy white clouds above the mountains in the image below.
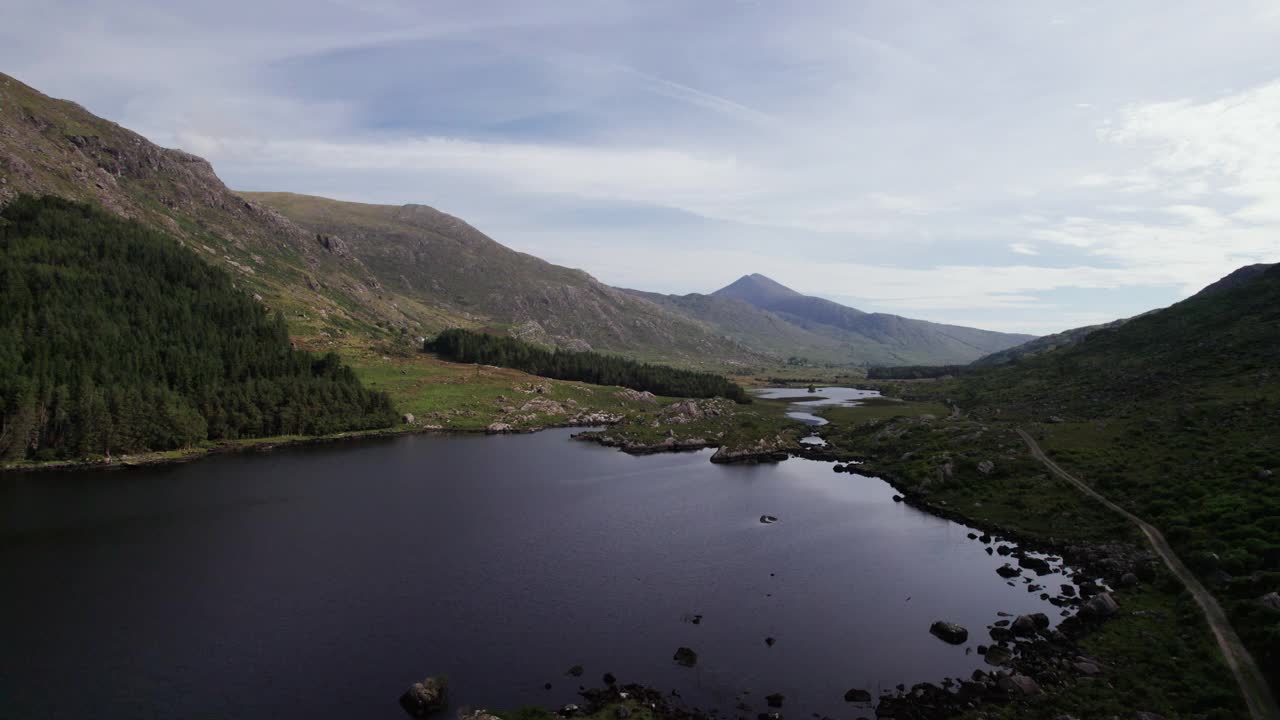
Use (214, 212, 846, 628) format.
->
(0, 0, 1280, 334)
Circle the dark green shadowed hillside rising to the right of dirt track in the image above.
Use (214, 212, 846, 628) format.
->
(850, 268, 1280, 691)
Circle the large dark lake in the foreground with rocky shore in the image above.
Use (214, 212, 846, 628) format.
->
(0, 422, 1065, 720)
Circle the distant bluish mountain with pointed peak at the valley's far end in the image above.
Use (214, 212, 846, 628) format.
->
(643, 269, 1032, 365)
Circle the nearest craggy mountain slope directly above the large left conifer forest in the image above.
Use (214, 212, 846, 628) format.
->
(0, 74, 431, 345)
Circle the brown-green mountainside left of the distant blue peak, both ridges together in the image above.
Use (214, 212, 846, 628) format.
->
(0, 74, 769, 366)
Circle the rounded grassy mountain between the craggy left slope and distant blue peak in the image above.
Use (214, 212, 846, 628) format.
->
(236, 192, 768, 368)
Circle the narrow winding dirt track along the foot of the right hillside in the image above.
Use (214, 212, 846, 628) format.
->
(1018, 428, 1280, 720)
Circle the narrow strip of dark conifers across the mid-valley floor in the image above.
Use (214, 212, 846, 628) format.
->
(422, 328, 751, 404)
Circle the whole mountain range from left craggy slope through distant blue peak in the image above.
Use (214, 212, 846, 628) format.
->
(0, 74, 1030, 368)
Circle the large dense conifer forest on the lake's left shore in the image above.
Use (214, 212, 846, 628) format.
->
(0, 196, 396, 460)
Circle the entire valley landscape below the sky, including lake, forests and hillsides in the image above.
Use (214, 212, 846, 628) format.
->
(0, 65, 1280, 720)
